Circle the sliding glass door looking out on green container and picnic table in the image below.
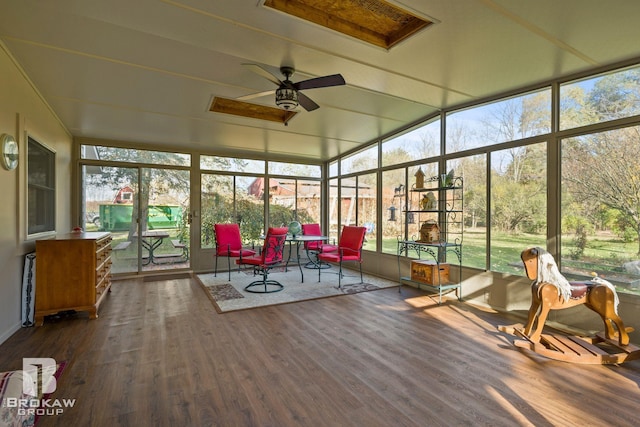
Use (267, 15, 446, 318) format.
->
(81, 149, 191, 274)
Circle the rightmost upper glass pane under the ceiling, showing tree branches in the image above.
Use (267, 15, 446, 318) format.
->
(560, 66, 640, 129)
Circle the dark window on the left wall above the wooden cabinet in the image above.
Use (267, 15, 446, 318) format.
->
(27, 137, 56, 237)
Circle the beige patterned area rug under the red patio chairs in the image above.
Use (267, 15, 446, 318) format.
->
(196, 266, 399, 313)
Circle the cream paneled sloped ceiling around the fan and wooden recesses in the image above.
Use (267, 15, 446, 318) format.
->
(0, 0, 640, 161)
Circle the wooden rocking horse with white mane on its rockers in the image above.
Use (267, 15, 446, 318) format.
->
(498, 248, 640, 364)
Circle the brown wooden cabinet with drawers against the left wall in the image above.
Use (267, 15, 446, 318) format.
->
(35, 232, 111, 326)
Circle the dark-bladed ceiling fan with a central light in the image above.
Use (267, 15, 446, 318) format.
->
(237, 64, 345, 111)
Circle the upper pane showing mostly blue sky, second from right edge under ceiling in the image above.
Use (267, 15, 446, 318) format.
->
(446, 89, 551, 153)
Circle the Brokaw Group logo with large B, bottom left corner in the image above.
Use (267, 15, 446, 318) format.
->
(2, 357, 76, 418)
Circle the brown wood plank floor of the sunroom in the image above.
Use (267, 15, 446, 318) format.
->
(0, 278, 640, 427)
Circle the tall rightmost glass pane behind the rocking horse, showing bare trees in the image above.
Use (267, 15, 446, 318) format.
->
(561, 126, 640, 293)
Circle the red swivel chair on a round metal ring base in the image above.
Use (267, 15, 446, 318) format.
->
(236, 227, 289, 294)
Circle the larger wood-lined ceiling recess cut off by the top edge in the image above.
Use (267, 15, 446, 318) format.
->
(263, 0, 434, 49)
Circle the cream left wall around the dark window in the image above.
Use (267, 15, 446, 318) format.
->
(0, 42, 72, 343)
